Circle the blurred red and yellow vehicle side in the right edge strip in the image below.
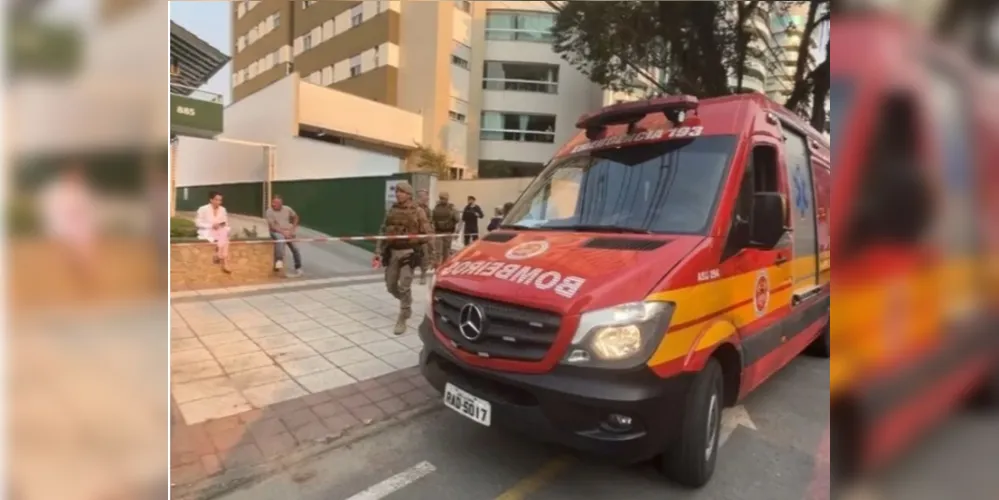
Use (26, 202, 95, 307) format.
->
(830, 2, 999, 499)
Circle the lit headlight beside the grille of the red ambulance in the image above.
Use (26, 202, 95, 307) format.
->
(562, 302, 674, 368)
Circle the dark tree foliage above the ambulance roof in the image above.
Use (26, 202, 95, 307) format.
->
(549, 0, 830, 129)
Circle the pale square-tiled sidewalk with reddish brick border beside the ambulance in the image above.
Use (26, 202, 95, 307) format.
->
(170, 273, 437, 494)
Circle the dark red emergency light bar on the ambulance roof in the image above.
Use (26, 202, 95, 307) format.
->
(576, 95, 699, 141)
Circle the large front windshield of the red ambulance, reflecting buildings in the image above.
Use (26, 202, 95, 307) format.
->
(504, 135, 736, 234)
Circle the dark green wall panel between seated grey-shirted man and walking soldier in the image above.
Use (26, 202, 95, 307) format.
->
(273, 177, 400, 250)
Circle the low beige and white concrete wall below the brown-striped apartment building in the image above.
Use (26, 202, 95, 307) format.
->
(175, 74, 422, 187)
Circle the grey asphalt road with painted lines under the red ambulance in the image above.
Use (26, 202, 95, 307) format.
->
(223, 357, 829, 500)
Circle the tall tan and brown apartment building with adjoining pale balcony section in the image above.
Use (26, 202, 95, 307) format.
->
(232, 0, 628, 177)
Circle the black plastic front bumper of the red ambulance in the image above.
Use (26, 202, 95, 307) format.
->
(419, 321, 691, 463)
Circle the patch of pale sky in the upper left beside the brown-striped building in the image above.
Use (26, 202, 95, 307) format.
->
(170, 1, 232, 105)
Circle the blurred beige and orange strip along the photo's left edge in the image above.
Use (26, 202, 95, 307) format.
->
(4, 1, 169, 500)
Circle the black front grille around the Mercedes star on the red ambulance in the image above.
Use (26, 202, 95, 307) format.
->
(433, 288, 562, 361)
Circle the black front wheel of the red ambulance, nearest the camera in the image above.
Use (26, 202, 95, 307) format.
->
(660, 358, 725, 488)
